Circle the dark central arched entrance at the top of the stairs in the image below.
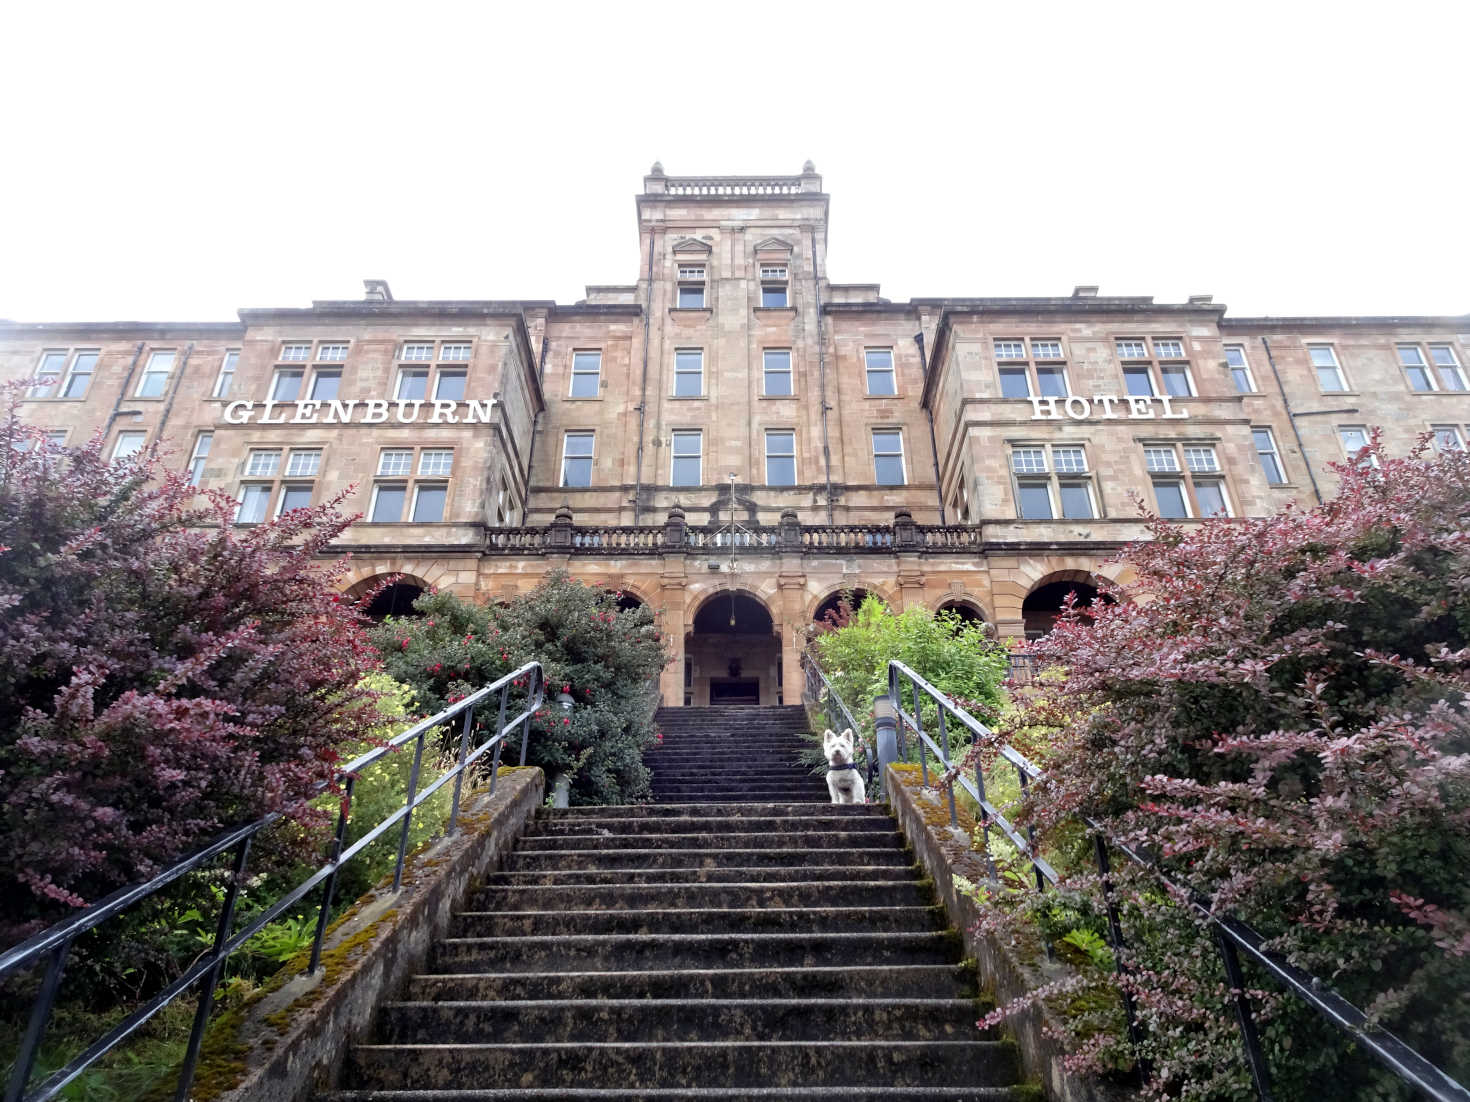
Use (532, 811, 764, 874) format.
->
(684, 589, 784, 707)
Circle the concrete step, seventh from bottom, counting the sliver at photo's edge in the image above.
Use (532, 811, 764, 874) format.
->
(469, 880, 932, 912)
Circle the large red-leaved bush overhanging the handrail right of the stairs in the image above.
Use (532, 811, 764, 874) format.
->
(983, 442, 1470, 1099)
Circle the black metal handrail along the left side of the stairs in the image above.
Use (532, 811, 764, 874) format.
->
(0, 663, 545, 1102)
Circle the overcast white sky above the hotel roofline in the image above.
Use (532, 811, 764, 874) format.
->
(0, 0, 1470, 322)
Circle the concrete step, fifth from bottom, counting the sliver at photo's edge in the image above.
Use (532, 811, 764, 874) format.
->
(432, 930, 960, 971)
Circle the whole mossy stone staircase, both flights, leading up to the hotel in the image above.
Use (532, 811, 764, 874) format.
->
(320, 708, 1035, 1102)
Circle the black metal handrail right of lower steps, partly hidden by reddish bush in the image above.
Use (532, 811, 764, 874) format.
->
(888, 660, 1470, 1102)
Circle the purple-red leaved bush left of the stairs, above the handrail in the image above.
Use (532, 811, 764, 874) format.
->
(0, 388, 378, 943)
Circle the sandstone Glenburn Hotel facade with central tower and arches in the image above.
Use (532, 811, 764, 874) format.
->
(0, 163, 1470, 704)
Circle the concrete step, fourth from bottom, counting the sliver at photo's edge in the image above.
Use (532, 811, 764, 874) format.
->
(404, 962, 978, 1002)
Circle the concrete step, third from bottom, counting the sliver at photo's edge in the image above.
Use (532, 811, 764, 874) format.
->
(378, 998, 983, 1045)
